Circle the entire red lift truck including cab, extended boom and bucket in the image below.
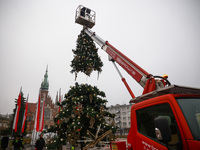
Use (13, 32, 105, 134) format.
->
(75, 5, 200, 150)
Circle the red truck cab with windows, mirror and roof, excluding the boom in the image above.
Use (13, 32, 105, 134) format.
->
(127, 85, 200, 150)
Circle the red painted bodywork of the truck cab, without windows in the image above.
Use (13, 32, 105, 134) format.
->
(127, 94, 200, 150)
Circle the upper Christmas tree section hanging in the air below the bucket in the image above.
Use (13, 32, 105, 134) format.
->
(71, 30, 103, 77)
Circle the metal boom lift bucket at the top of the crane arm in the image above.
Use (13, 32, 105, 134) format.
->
(75, 5, 96, 28)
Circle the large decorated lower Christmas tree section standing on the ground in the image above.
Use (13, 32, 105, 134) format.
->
(47, 83, 116, 149)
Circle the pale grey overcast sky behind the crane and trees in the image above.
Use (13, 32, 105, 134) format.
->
(0, 0, 200, 114)
